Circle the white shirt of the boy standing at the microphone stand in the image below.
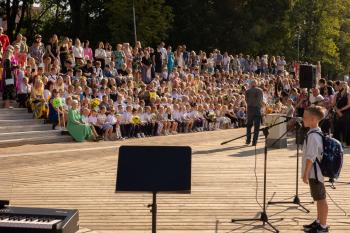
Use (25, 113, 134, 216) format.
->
(301, 128, 324, 183)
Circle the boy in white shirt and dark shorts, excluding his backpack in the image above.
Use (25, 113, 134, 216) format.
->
(302, 106, 328, 233)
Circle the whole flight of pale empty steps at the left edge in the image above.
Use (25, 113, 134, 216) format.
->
(0, 106, 73, 148)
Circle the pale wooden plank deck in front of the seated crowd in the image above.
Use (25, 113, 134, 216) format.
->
(0, 130, 350, 233)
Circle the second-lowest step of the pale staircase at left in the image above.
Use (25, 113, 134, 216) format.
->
(0, 130, 62, 141)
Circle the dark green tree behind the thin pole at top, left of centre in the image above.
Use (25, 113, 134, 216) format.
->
(105, 0, 173, 45)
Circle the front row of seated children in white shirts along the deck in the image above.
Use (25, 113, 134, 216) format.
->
(76, 104, 244, 140)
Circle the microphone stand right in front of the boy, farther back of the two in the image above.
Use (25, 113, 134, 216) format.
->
(268, 121, 313, 213)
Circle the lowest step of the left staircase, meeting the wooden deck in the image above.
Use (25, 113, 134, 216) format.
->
(0, 135, 73, 148)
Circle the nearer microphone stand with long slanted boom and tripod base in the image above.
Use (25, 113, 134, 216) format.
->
(221, 120, 287, 233)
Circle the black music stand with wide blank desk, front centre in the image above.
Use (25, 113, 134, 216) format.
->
(116, 146, 192, 233)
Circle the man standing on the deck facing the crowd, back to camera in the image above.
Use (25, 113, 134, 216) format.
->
(245, 80, 263, 146)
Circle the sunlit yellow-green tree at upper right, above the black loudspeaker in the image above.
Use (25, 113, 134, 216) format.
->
(291, 0, 343, 74)
